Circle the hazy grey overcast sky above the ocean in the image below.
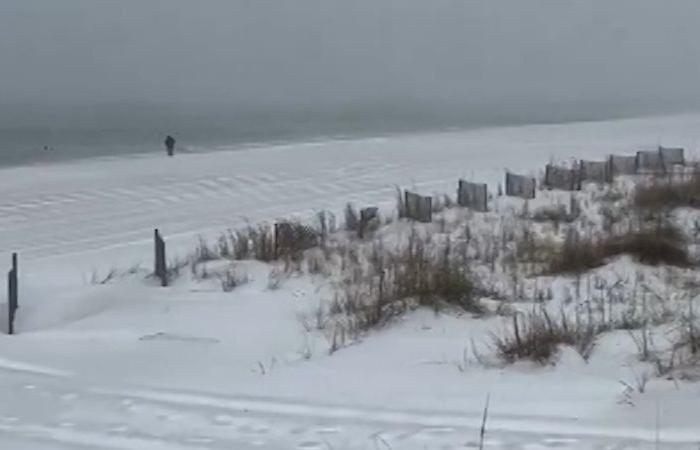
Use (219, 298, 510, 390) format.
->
(0, 0, 700, 114)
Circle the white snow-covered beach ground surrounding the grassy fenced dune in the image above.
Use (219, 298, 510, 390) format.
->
(0, 116, 700, 450)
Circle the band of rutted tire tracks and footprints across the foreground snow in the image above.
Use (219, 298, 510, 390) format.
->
(0, 373, 697, 450)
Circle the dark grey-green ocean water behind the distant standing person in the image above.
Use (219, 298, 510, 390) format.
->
(0, 104, 680, 166)
